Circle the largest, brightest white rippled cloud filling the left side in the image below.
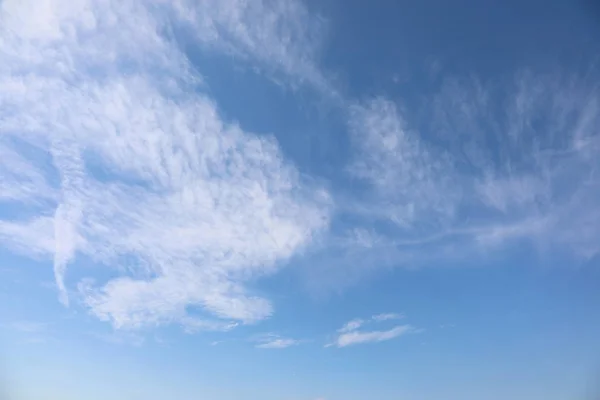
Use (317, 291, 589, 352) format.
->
(0, 0, 330, 330)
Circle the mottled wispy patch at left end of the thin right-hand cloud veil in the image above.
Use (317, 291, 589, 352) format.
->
(349, 98, 460, 231)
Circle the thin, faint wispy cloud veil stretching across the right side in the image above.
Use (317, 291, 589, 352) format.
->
(348, 74, 600, 265)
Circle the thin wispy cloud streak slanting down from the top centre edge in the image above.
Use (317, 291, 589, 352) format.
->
(174, 0, 337, 97)
